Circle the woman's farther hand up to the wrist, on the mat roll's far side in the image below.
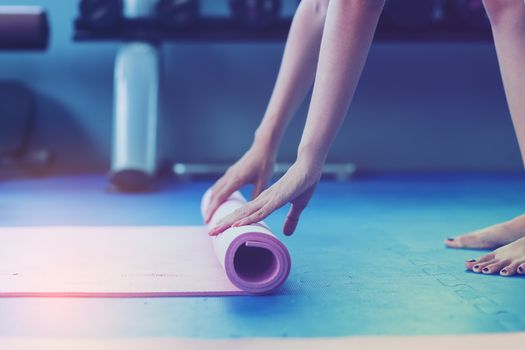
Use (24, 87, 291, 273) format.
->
(204, 143, 276, 223)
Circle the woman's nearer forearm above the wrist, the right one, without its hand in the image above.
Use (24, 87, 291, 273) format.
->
(298, 0, 383, 164)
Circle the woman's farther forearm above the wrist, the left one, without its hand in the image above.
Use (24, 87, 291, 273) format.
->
(255, 0, 328, 152)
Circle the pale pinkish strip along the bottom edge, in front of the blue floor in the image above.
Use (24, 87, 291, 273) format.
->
(0, 333, 525, 350)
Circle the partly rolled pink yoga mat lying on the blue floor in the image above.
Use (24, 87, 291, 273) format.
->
(0, 191, 290, 297)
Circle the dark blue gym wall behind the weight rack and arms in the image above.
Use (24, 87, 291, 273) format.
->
(0, 0, 522, 172)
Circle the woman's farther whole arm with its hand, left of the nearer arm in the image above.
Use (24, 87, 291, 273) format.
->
(204, 0, 329, 223)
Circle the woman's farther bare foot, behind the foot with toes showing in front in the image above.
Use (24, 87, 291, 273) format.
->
(445, 214, 525, 249)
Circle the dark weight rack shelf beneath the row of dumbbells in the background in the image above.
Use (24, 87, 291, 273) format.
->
(73, 17, 492, 42)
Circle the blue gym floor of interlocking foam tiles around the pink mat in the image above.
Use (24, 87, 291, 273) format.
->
(0, 175, 525, 338)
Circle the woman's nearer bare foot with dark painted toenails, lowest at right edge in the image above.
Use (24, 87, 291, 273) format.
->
(465, 237, 525, 276)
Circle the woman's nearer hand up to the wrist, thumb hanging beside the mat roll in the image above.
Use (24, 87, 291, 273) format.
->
(209, 157, 323, 236)
